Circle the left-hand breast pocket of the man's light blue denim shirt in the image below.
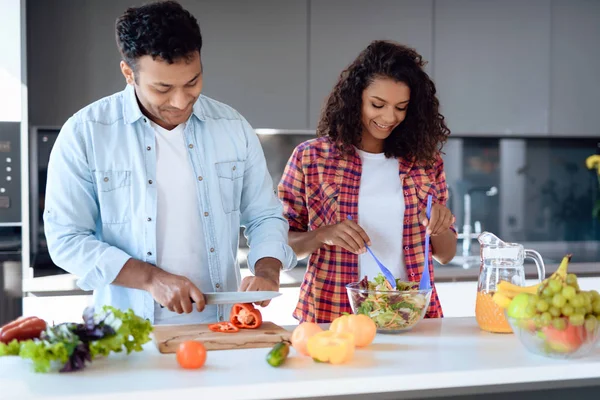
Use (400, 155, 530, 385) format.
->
(95, 171, 131, 224)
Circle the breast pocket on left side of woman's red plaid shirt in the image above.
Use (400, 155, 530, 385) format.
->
(307, 182, 339, 229)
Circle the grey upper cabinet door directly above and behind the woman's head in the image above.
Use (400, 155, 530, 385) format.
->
(308, 0, 433, 129)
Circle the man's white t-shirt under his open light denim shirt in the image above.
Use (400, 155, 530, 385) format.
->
(152, 123, 217, 324)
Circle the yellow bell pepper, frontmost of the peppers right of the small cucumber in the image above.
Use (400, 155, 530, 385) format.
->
(306, 331, 354, 364)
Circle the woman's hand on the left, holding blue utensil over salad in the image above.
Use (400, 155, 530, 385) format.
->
(316, 219, 371, 254)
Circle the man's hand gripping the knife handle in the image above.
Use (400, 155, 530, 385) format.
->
(148, 268, 205, 314)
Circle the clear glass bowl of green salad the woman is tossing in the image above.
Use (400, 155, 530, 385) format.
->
(346, 282, 432, 333)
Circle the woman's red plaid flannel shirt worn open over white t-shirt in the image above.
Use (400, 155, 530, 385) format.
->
(278, 137, 456, 323)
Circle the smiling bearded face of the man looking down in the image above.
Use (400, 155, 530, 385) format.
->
(121, 52, 202, 130)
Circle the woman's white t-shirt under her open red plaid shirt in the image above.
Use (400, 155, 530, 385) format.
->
(357, 149, 407, 281)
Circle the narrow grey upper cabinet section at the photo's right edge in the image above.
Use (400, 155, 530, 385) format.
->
(550, 0, 600, 137)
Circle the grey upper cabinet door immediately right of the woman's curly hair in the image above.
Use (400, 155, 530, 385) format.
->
(433, 0, 552, 136)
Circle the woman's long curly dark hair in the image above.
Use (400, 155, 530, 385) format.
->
(317, 40, 450, 165)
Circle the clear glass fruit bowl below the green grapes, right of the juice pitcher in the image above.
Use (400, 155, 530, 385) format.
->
(506, 315, 600, 359)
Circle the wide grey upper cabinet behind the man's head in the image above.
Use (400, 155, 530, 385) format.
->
(27, 0, 308, 129)
